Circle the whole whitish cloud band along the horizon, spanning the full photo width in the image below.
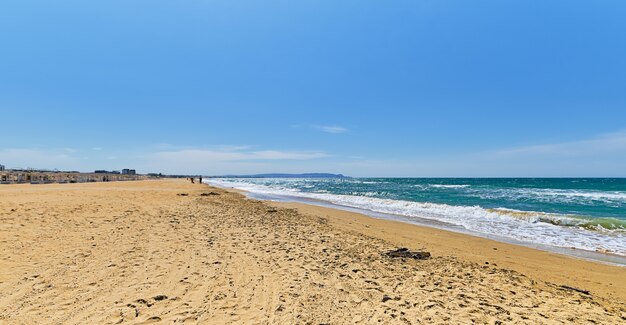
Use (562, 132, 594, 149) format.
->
(0, 131, 626, 177)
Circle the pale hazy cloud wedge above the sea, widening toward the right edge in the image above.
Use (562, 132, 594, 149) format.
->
(337, 131, 626, 177)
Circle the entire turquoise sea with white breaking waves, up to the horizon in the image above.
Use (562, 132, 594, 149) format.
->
(209, 178, 626, 256)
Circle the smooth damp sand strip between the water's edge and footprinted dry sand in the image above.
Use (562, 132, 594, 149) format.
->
(213, 184, 626, 301)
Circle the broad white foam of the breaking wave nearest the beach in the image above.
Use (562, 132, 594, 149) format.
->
(210, 179, 626, 256)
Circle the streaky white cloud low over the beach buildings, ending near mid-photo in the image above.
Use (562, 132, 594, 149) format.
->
(0, 145, 330, 174)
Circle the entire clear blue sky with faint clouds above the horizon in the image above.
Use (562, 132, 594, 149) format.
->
(0, 0, 626, 176)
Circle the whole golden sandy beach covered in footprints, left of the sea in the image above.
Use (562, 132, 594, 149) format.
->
(0, 180, 626, 324)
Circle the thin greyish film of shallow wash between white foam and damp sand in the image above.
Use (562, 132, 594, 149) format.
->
(210, 180, 626, 268)
